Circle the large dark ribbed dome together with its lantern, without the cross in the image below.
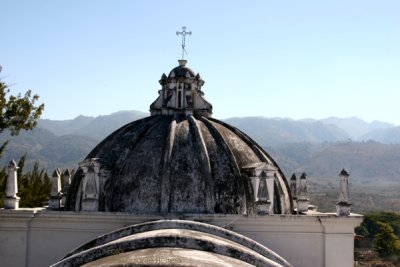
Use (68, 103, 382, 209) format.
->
(65, 61, 293, 214)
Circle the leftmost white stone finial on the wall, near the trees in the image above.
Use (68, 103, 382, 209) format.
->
(4, 160, 20, 209)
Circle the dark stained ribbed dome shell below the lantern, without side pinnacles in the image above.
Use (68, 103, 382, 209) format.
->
(66, 115, 291, 214)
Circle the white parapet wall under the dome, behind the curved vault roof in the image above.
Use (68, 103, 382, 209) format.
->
(0, 209, 362, 267)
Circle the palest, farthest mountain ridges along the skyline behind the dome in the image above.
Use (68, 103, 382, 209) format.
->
(38, 111, 400, 145)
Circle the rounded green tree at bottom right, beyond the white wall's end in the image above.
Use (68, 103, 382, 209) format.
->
(375, 222, 400, 258)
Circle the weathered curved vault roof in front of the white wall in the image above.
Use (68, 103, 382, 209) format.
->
(53, 220, 291, 266)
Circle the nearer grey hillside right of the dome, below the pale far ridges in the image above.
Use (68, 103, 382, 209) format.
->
(267, 141, 400, 182)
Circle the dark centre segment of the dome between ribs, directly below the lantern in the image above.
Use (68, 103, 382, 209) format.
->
(164, 116, 214, 213)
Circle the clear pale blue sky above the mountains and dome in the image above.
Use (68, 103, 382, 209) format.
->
(0, 0, 400, 125)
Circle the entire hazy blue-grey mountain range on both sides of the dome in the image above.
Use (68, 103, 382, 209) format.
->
(0, 111, 400, 181)
